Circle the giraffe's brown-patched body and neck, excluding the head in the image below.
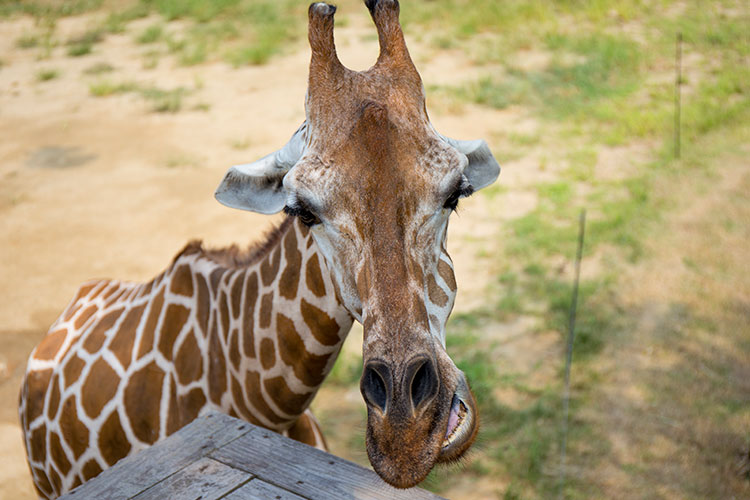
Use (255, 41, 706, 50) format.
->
(19, 218, 352, 498)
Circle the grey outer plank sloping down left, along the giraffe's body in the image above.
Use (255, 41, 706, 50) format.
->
(60, 413, 254, 500)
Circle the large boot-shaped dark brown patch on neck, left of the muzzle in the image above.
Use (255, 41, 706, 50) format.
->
(276, 314, 328, 387)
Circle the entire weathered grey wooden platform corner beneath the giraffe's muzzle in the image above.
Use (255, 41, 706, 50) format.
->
(61, 414, 440, 500)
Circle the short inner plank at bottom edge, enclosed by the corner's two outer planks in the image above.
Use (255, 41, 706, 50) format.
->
(133, 457, 253, 500)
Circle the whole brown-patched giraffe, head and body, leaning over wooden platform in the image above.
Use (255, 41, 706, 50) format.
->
(19, 0, 500, 497)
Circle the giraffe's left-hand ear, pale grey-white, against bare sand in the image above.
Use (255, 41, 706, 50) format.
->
(214, 122, 307, 215)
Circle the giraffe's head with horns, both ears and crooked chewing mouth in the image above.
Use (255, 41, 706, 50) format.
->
(216, 0, 500, 487)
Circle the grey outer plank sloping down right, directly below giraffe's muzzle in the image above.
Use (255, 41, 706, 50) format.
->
(209, 428, 440, 500)
